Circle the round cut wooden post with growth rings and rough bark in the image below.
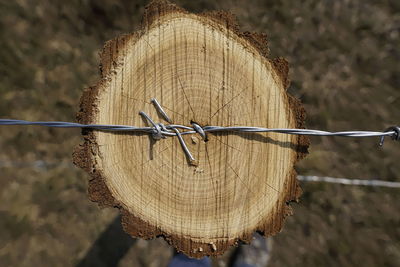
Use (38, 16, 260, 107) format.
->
(74, 1, 308, 257)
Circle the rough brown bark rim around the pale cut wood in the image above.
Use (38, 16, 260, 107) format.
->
(73, 0, 310, 258)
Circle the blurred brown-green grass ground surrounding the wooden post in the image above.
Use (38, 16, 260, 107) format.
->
(0, 0, 400, 266)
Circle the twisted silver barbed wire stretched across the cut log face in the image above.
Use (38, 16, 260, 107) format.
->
(0, 98, 400, 165)
